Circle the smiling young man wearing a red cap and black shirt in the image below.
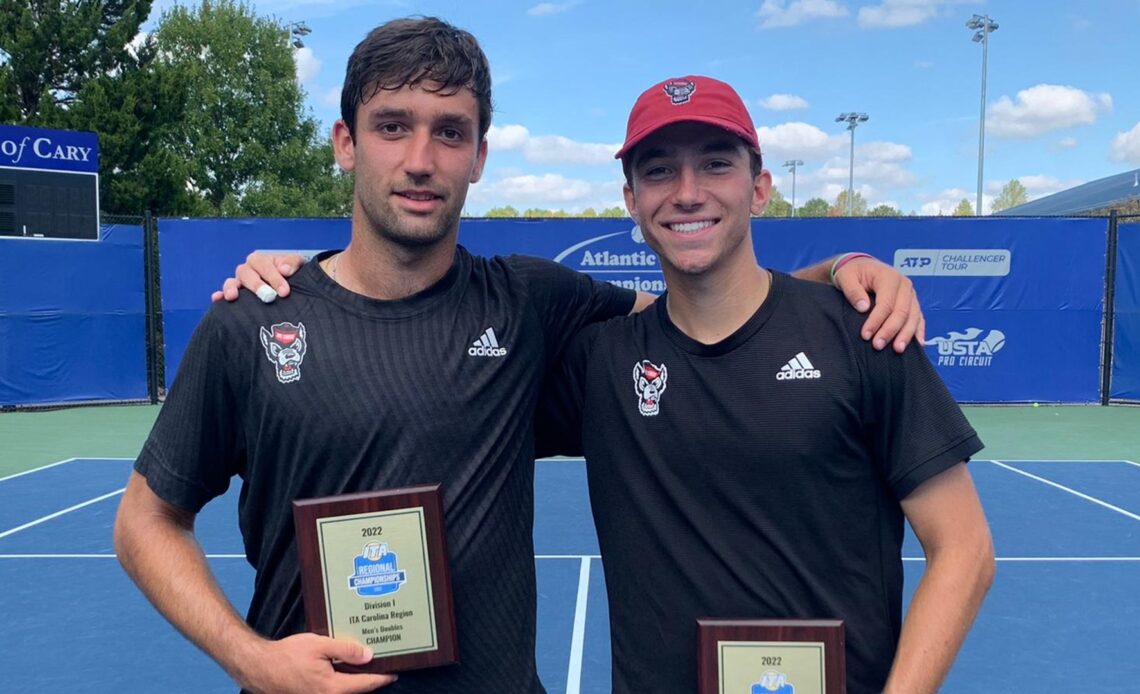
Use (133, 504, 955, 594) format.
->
(539, 76, 994, 694)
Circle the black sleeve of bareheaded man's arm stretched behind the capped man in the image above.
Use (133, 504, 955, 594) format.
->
(507, 255, 637, 360)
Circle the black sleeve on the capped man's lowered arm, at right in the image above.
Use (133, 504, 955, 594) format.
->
(847, 310, 983, 499)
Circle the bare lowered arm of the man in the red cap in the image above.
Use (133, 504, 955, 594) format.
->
(884, 463, 995, 694)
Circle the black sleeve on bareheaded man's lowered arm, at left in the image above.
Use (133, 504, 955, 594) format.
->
(135, 307, 244, 513)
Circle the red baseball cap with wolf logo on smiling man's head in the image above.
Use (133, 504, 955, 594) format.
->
(613, 75, 760, 160)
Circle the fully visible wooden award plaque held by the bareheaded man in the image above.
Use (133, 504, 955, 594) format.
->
(293, 485, 457, 672)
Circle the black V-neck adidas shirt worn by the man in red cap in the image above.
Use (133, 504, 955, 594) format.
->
(539, 272, 982, 694)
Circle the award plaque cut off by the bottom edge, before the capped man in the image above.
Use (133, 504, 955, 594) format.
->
(697, 619, 847, 694)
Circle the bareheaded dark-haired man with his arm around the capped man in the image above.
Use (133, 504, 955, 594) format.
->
(115, 17, 934, 694)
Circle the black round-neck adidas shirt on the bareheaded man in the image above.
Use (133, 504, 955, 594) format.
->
(136, 247, 634, 694)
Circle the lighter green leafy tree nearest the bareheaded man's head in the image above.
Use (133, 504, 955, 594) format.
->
(155, 0, 321, 214)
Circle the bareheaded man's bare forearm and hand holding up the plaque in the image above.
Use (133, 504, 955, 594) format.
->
(114, 472, 394, 694)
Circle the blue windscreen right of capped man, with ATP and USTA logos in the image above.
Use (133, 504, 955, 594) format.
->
(757, 217, 1108, 402)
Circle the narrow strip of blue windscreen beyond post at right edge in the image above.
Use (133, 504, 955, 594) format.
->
(1109, 222, 1140, 401)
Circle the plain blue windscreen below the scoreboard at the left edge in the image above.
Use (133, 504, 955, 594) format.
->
(0, 224, 147, 406)
